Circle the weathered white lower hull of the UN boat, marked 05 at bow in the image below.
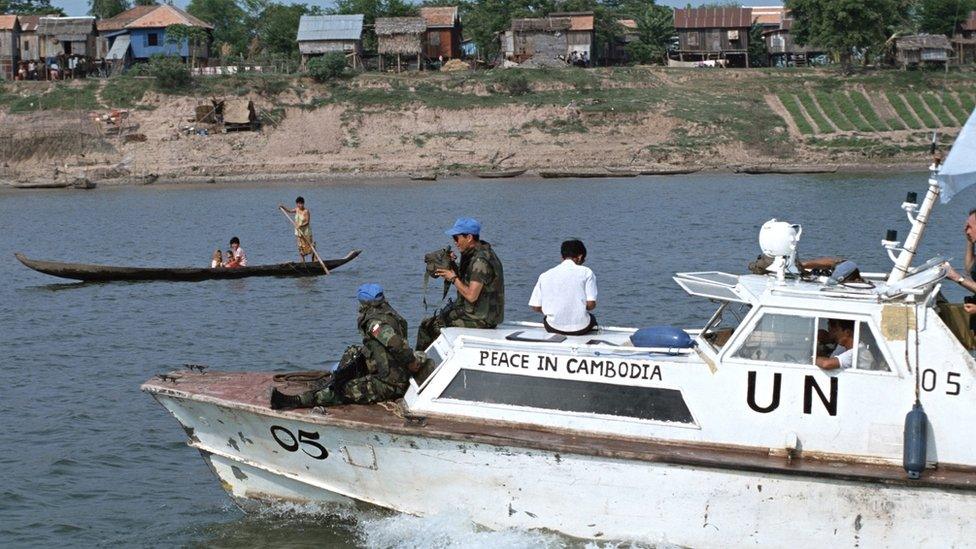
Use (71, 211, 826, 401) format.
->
(144, 387, 976, 547)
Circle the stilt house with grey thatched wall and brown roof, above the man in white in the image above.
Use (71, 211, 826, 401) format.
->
(501, 11, 594, 66)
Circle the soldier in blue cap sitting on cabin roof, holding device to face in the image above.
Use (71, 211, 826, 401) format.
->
(416, 217, 505, 351)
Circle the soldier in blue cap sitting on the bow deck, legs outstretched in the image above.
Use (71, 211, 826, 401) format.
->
(271, 284, 418, 410)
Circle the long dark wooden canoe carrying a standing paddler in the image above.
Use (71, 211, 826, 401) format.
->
(14, 250, 361, 282)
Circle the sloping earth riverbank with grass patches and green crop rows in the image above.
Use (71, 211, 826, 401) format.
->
(0, 67, 976, 185)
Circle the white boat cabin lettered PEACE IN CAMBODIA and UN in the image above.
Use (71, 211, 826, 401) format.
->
(405, 261, 976, 463)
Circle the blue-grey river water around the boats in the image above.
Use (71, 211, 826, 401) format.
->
(0, 173, 973, 547)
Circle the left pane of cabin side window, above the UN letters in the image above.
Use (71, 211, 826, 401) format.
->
(735, 314, 814, 364)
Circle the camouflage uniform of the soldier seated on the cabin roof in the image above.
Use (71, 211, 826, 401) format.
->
(417, 242, 505, 351)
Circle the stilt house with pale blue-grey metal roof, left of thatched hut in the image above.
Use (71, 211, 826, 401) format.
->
(298, 15, 363, 68)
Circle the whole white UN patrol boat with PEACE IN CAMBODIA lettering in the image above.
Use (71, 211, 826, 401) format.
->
(143, 111, 976, 547)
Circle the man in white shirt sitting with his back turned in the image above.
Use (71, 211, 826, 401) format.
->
(529, 240, 596, 335)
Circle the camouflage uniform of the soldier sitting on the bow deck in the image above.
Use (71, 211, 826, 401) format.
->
(300, 300, 414, 407)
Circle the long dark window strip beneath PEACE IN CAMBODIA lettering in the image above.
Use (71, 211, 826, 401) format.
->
(440, 369, 694, 423)
